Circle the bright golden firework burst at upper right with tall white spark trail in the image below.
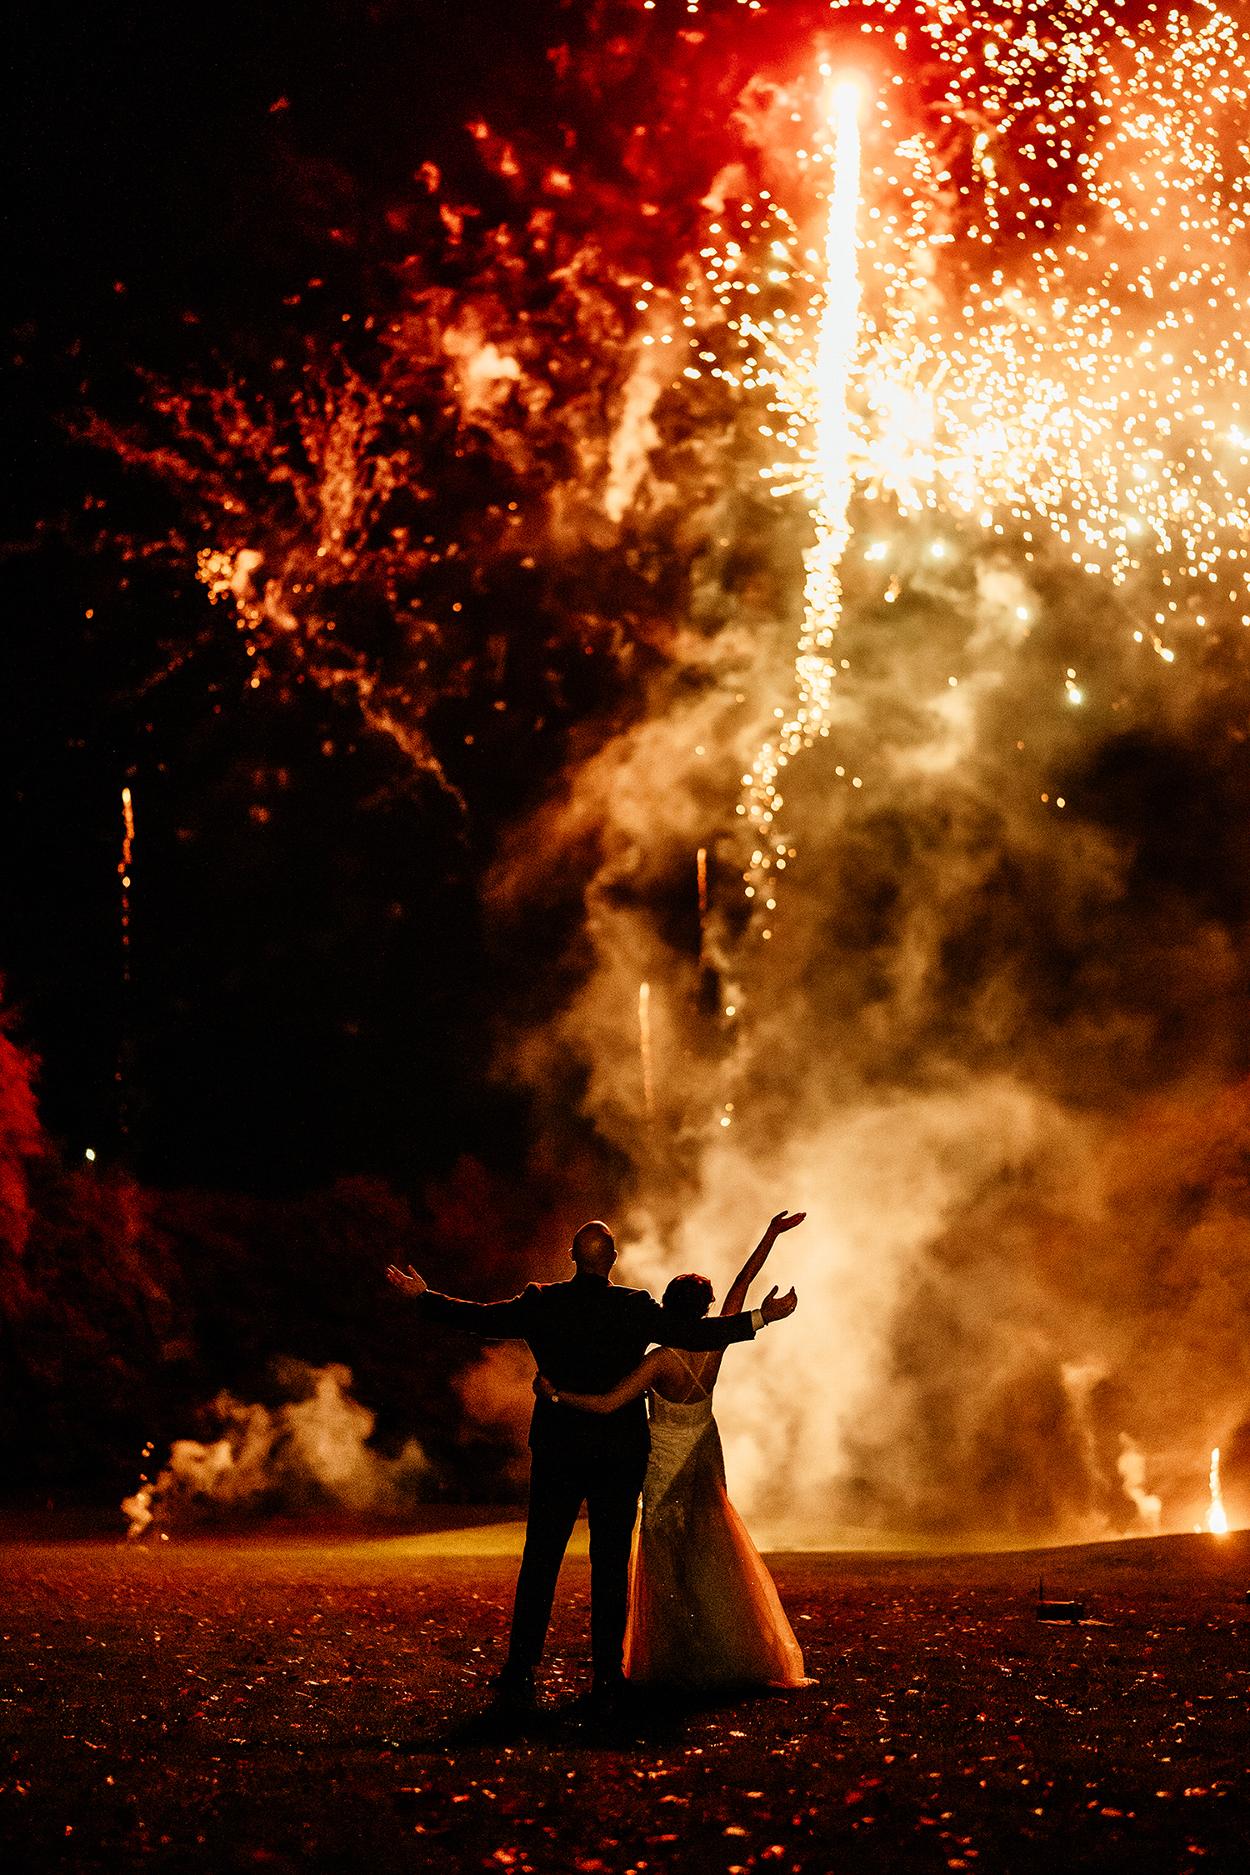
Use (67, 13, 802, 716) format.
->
(684, 0, 1250, 907)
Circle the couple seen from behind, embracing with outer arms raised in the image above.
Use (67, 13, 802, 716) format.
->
(386, 1211, 806, 1716)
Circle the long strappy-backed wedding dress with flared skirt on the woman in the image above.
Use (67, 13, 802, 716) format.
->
(624, 1391, 810, 1688)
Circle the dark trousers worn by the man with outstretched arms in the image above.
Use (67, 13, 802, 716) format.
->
(504, 1448, 647, 1686)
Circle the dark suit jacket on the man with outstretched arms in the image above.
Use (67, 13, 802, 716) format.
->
(418, 1269, 753, 1453)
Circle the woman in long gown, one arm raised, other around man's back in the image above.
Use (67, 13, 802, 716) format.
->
(536, 1211, 810, 1688)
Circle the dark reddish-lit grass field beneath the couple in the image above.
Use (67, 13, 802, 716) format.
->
(0, 1532, 1250, 1875)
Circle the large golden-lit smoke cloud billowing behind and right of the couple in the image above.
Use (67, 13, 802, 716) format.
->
(499, 438, 1250, 1541)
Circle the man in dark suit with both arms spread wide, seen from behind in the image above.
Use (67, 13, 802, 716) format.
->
(386, 1219, 796, 1714)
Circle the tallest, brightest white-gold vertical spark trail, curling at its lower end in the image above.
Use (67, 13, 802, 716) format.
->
(744, 68, 860, 911)
